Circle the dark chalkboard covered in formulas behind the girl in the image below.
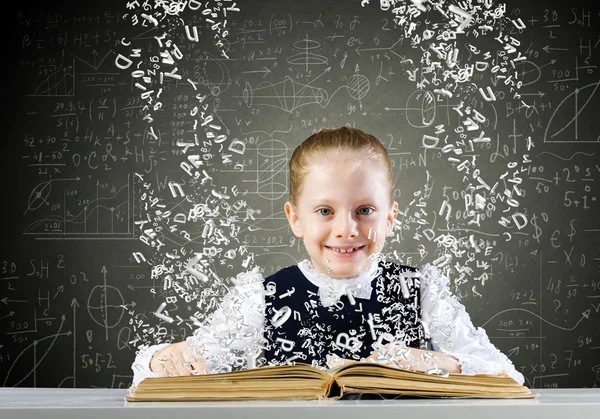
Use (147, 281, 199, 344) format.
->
(0, 0, 600, 388)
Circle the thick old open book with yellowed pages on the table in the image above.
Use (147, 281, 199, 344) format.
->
(126, 362, 537, 402)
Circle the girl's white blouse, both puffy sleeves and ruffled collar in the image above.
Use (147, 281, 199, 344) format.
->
(132, 260, 524, 386)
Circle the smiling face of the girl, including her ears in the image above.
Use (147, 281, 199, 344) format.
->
(284, 151, 398, 278)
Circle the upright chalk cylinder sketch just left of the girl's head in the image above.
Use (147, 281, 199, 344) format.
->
(256, 139, 288, 201)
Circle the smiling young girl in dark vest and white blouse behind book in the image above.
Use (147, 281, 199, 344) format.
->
(133, 127, 523, 385)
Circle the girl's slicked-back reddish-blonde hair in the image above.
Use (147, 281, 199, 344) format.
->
(289, 127, 394, 206)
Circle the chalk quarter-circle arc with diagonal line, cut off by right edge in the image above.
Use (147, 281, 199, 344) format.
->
(544, 80, 600, 143)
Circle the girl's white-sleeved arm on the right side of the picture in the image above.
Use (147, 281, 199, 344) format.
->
(419, 264, 524, 384)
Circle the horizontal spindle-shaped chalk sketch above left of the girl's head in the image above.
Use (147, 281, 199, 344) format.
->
(243, 76, 329, 113)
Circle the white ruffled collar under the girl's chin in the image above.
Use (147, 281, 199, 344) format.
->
(298, 258, 381, 307)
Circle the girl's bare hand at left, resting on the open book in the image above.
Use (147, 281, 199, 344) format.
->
(150, 341, 206, 377)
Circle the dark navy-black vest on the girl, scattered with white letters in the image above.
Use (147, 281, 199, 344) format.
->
(264, 261, 425, 367)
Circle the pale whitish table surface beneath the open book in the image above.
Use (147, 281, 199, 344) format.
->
(0, 388, 600, 419)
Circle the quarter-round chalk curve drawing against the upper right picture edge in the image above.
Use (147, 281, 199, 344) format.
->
(544, 80, 600, 143)
